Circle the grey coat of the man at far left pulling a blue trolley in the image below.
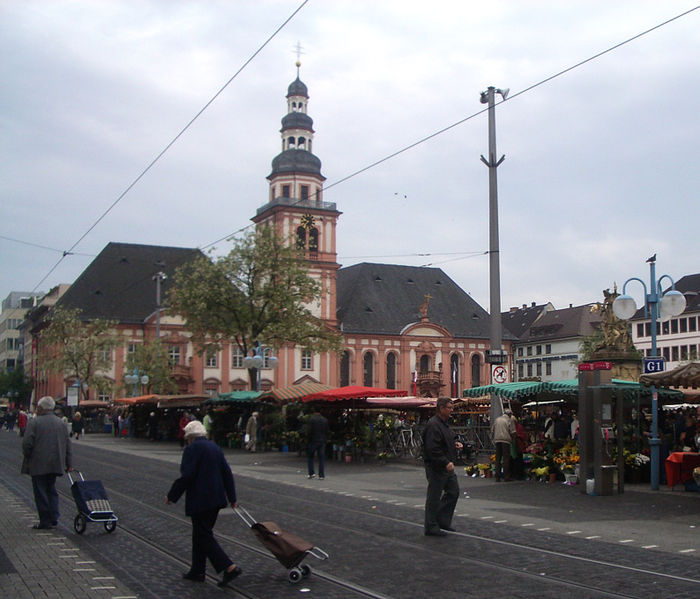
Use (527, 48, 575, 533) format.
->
(22, 413, 72, 476)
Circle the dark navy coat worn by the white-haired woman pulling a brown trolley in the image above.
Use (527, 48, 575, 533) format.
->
(168, 437, 236, 516)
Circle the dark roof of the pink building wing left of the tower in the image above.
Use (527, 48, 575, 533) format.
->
(58, 242, 200, 323)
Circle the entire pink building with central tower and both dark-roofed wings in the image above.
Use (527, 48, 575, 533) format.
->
(32, 68, 508, 400)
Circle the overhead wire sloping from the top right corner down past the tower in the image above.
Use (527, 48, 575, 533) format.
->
(199, 5, 700, 255)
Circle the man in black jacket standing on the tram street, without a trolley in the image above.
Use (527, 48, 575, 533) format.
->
(423, 397, 462, 537)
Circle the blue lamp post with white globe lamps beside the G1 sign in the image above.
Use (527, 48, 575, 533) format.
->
(613, 254, 686, 491)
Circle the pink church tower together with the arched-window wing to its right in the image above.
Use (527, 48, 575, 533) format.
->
(249, 70, 512, 397)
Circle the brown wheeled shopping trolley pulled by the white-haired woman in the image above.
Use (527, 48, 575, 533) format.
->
(235, 507, 329, 583)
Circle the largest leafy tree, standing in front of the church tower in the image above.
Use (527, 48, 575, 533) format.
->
(170, 227, 342, 389)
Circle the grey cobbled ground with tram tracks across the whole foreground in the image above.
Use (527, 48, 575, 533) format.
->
(0, 432, 700, 599)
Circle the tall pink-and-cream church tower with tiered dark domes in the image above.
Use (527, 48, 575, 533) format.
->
(251, 61, 341, 384)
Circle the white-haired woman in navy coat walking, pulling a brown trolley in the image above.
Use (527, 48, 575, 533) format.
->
(165, 420, 242, 586)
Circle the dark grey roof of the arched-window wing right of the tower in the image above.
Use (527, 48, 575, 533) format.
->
(337, 262, 513, 340)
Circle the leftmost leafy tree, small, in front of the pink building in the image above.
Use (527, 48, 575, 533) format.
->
(39, 307, 121, 400)
